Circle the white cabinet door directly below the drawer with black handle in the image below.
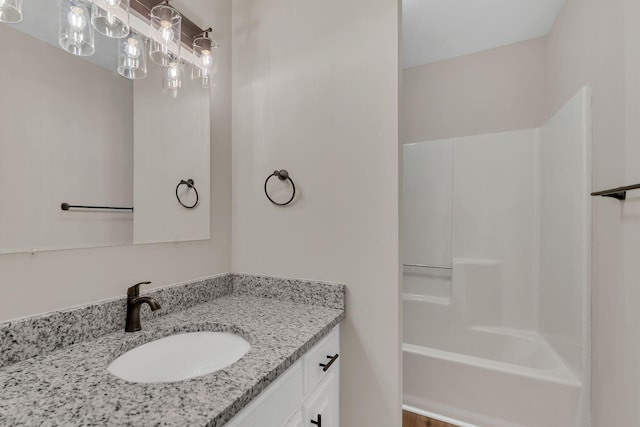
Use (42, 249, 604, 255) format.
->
(303, 370, 340, 427)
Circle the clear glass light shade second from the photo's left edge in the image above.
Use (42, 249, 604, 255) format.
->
(58, 0, 96, 56)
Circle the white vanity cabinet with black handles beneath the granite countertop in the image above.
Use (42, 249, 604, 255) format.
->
(226, 326, 340, 427)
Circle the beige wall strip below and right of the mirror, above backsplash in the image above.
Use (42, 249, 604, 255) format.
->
(0, 0, 231, 320)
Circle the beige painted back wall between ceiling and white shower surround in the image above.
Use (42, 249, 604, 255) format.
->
(402, 38, 544, 143)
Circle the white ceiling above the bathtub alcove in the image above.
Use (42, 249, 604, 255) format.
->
(402, 0, 565, 68)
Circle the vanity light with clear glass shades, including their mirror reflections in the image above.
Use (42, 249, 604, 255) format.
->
(49, 0, 219, 91)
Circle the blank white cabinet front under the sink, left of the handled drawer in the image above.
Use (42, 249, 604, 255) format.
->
(225, 360, 303, 427)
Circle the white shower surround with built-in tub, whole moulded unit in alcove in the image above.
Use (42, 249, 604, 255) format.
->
(403, 87, 591, 427)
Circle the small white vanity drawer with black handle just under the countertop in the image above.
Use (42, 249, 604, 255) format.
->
(304, 326, 340, 395)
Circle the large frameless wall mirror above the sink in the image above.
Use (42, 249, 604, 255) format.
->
(0, 0, 210, 253)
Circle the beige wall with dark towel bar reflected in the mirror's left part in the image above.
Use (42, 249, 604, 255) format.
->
(0, 25, 133, 253)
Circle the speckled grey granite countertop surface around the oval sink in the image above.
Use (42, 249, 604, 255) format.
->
(0, 294, 345, 426)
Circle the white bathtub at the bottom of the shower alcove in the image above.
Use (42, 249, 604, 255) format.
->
(403, 297, 587, 427)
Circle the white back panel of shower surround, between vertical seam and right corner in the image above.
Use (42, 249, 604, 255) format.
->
(453, 129, 538, 329)
